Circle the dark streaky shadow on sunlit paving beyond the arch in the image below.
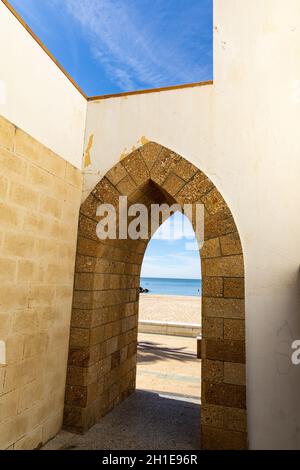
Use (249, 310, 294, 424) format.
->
(138, 341, 197, 364)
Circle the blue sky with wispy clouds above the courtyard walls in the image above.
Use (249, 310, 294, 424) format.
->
(10, 0, 213, 95)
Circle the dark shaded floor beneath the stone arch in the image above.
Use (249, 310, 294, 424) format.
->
(44, 390, 200, 450)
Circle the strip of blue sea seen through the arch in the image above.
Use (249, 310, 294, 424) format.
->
(141, 277, 201, 297)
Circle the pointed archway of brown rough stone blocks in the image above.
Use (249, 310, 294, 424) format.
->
(64, 142, 247, 449)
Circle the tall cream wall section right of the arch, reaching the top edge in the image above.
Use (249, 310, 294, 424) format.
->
(211, 0, 300, 449)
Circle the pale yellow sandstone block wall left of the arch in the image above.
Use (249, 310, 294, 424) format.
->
(0, 117, 82, 449)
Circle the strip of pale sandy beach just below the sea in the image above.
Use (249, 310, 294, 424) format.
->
(139, 294, 201, 323)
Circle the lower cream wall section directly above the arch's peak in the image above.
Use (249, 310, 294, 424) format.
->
(83, 85, 212, 198)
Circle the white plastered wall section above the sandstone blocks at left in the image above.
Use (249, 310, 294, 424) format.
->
(0, 2, 86, 168)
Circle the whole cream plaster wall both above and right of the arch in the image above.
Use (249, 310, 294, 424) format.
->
(83, 0, 300, 449)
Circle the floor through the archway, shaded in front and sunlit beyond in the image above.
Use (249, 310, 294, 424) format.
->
(43, 334, 200, 450)
